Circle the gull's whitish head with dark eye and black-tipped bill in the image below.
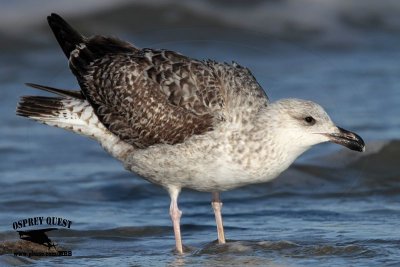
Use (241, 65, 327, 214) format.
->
(269, 99, 365, 152)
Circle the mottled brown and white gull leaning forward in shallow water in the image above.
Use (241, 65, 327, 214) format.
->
(17, 14, 365, 253)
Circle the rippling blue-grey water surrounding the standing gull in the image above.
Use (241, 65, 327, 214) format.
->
(0, 0, 400, 266)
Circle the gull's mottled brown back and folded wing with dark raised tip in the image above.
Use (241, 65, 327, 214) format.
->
(49, 13, 268, 148)
